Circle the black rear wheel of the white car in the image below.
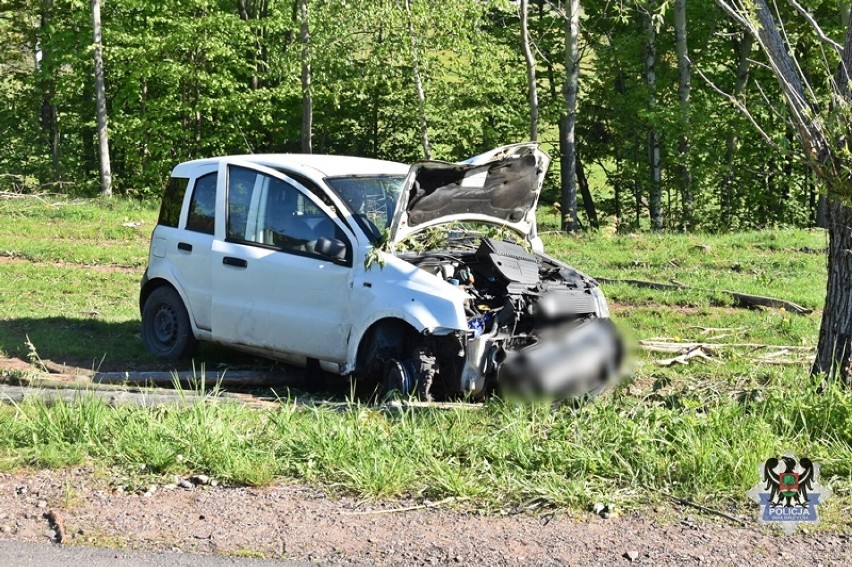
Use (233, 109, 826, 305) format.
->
(142, 286, 198, 360)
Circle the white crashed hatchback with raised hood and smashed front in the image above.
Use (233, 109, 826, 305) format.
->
(139, 144, 621, 398)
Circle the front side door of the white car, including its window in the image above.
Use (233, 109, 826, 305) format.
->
(212, 160, 355, 362)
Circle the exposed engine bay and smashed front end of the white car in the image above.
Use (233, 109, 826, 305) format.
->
(392, 238, 622, 397)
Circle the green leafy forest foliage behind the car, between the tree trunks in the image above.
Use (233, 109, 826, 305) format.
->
(0, 0, 843, 226)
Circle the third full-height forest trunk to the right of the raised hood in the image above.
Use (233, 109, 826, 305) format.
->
(674, 0, 695, 230)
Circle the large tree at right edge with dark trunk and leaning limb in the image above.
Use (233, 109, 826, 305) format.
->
(716, 0, 852, 384)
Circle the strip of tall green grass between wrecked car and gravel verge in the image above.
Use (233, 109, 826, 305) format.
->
(0, 375, 852, 506)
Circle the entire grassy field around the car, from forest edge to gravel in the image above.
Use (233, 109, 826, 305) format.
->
(0, 200, 852, 528)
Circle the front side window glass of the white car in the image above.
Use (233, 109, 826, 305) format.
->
(226, 166, 351, 258)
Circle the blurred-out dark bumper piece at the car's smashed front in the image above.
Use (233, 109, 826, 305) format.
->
(498, 319, 624, 397)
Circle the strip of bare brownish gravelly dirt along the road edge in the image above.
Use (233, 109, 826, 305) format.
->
(0, 469, 852, 566)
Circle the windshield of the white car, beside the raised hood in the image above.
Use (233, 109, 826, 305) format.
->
(326, 175, 405, 242)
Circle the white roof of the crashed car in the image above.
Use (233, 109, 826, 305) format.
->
(172, 154, 409, 177)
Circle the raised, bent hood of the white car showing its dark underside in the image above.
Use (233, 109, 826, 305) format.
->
(390, 143, 550, 247)
